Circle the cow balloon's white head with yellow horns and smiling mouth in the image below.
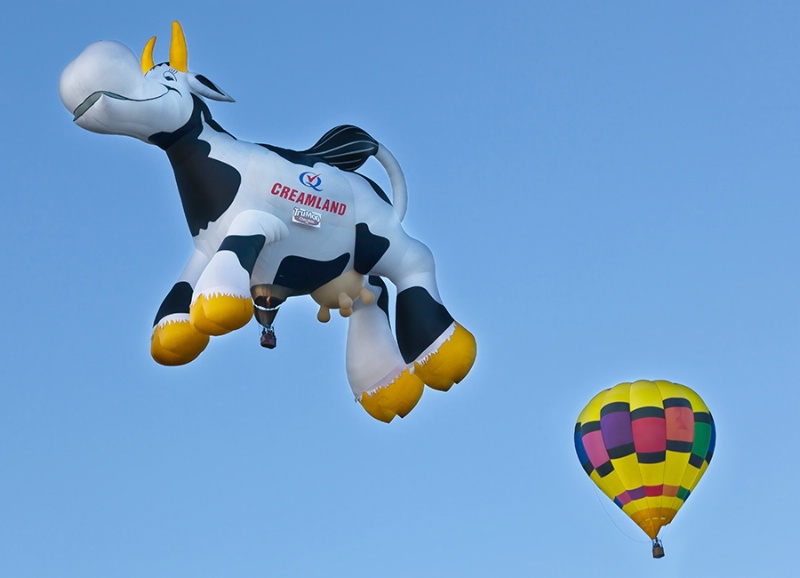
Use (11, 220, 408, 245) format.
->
(58, 22, 233, 142)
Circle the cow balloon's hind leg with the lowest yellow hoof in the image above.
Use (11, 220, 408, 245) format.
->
(347, 277, 424, 423)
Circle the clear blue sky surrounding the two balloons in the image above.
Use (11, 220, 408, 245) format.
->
(0, 0, 800, 578)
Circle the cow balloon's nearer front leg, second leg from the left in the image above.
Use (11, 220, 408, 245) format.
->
(190, 210, 288, 335)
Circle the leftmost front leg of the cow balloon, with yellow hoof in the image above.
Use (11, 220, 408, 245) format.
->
(150, 250, 208, 365)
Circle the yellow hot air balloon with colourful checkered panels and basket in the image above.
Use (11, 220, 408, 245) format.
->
(575, 380, 716, 558)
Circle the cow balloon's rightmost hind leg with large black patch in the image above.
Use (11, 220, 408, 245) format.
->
(374, 228, 477, 391)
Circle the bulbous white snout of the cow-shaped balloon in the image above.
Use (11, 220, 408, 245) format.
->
(58, 40, 143, 113)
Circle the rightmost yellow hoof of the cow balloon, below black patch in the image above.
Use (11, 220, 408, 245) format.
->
(414, 323, 478, 391)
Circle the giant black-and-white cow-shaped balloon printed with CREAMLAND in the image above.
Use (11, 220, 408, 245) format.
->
(59, 22, 476, 422)
